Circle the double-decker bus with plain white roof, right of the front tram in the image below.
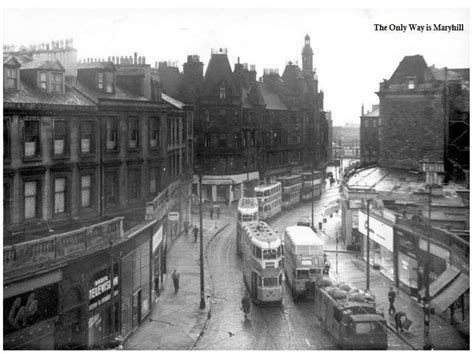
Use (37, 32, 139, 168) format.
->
(283, 226, 324, 298)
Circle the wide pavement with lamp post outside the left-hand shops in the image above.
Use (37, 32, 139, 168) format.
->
(123, 206, 235, 350)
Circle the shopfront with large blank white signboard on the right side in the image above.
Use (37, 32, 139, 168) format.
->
(358, 210, 395, 280)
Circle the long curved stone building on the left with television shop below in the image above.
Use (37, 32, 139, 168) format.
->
(3, 39, 194, 349)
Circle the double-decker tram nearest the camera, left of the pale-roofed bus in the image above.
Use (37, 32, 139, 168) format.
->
(240, 221, 283, 303)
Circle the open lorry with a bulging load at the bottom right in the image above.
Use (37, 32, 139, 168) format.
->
(315, 279, 387, 350)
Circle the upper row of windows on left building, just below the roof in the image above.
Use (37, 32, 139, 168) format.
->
(3, 118, 165, 159)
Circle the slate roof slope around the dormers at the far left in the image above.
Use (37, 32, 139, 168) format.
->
(3, 81, 95, 106)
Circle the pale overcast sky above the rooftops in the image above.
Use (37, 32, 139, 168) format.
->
(3, 2, 470, 125)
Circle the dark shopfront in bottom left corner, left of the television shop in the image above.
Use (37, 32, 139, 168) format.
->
(3, 271, 62, 350)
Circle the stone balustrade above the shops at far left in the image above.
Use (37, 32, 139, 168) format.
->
(3, 217, 123, 271)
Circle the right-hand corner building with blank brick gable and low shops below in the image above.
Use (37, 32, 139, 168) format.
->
(341, 55, 470, 330)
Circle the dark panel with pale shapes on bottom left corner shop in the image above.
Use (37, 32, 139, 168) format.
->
(3, 284, 58, 335)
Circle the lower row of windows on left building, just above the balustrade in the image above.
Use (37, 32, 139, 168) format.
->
(3, 167, 160, 223)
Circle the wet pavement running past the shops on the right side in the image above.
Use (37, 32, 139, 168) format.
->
(322, 214, 469, 350)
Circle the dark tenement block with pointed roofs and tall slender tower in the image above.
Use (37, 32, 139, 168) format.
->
(157, 36, 328, 202)
